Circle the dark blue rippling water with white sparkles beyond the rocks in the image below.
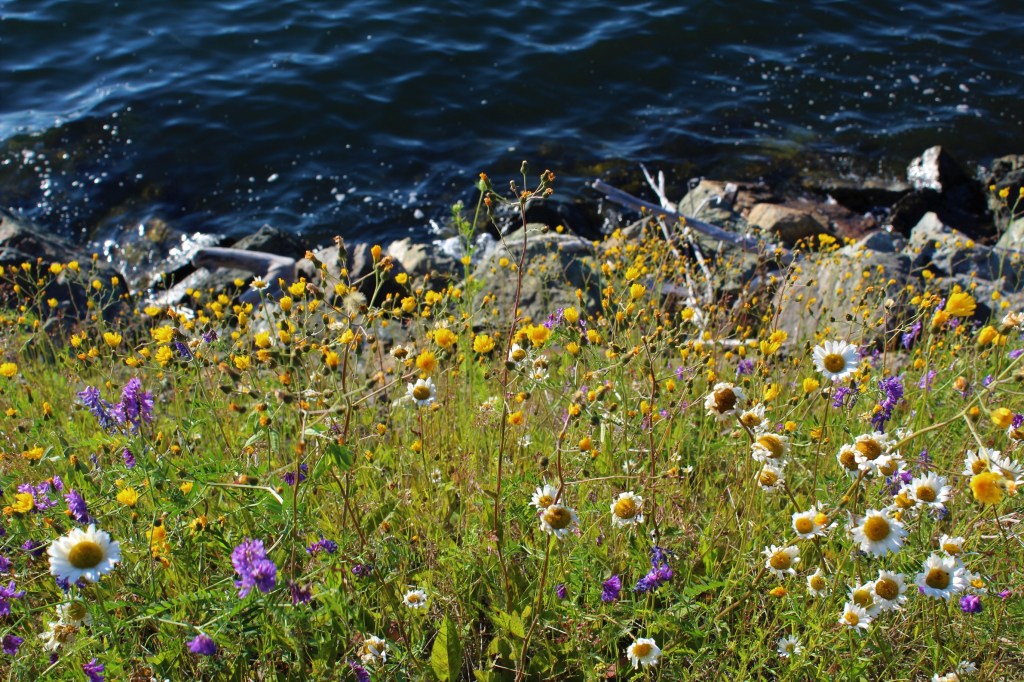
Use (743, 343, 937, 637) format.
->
(0, 0, 1024, 246)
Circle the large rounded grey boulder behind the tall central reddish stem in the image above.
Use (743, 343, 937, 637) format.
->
(473, 224, 601, 323)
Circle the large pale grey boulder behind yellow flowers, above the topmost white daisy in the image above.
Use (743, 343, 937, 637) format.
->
(774, 238, 910, 341)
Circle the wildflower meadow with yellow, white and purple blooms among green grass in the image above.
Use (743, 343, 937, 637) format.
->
(0, 165, 1024, 681)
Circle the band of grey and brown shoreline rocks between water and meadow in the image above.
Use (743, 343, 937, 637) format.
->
(0, 146, 1024, 337)
